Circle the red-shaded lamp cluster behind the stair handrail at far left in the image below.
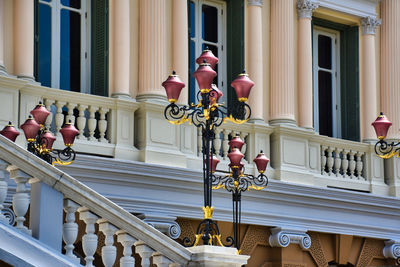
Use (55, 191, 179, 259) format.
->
(0, 102, 79, 165)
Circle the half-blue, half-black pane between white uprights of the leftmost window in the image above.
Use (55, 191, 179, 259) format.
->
(60, 9, 81, 92)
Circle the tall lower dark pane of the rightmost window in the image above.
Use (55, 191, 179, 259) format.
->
(318, 71, 332, 137)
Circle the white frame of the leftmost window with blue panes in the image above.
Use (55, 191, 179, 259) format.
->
(39, 0, 91, 93)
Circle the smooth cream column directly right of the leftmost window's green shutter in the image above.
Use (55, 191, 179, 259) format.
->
(110, 0, 131, 98)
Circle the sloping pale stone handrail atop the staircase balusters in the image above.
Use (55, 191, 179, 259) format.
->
(0, 135, 192, 265)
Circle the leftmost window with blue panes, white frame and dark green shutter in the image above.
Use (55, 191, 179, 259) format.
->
(35, 0, 108, 95)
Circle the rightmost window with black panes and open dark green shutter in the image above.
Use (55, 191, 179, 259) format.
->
(312, 18, 360, 141)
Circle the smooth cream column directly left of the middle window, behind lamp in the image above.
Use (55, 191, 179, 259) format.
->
(172, 0, 189, 104)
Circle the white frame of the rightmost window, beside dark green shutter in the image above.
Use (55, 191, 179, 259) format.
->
(313, 26, 342, 138)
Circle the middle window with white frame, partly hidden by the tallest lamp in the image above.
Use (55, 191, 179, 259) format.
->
(188, 0, 227, 103)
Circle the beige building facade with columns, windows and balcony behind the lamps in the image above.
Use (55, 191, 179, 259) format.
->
(0, 0, 400, 267)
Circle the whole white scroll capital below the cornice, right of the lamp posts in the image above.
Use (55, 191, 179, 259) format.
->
(269, 227, 311, 250)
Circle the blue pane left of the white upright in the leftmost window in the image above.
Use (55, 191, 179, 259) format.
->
(37, 4, 51, 87)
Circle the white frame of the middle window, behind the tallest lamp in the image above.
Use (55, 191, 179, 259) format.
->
(190, 0, 228, 103)
